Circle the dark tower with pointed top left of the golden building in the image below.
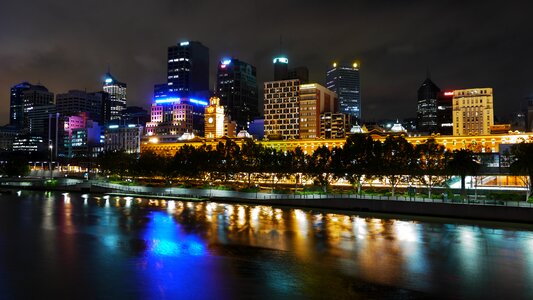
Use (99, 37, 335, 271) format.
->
(416, 76, 440, 134)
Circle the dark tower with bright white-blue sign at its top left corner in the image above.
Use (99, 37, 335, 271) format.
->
(216, 58, 259, 129)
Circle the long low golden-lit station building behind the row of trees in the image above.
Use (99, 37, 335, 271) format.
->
(141, 130, 533, 156)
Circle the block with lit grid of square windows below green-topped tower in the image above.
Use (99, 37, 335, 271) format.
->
(264, 79, 300, 139)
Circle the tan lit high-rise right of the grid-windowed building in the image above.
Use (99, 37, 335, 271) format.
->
(298, 83, 337, 139)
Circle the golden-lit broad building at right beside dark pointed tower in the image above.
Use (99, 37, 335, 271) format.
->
(453, 88, 494, 136)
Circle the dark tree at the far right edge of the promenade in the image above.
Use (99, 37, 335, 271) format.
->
(511, 142, 533, 199)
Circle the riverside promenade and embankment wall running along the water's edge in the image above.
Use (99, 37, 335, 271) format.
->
(1, 181, 533, 223)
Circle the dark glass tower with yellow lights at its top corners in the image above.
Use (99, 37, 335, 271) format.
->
(326, 63, 361, 119)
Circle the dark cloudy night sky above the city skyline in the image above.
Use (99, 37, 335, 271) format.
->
(0, 0, 533, 124)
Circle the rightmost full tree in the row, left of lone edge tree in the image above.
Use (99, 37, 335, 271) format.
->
(415, 138, 446, 198)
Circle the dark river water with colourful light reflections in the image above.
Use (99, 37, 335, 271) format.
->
(0, 191, 533, 299)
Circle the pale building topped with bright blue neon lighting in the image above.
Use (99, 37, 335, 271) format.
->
(146, 97, 208, 135)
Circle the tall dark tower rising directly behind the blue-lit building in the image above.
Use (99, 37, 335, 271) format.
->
(167, 41, 209, 97)
